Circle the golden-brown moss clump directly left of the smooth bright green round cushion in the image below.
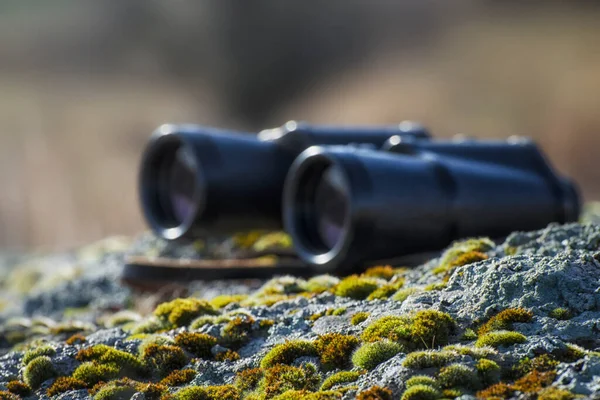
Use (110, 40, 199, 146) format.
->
(314, 333, 360, 371)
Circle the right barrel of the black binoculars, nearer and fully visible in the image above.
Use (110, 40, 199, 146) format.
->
(283, 136, 579, 273)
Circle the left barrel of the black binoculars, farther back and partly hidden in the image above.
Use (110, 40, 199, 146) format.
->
(139, 121, 429, 240)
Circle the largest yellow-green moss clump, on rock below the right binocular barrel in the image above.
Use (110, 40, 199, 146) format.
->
(361, 310, 455, 350)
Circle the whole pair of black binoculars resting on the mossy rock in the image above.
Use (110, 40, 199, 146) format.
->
(139, 121, 580, 273)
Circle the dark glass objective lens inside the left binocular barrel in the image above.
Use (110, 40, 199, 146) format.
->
(159, 146, 198, 225)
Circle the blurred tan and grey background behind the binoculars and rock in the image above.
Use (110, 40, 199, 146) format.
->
(0, 0, 600, 250)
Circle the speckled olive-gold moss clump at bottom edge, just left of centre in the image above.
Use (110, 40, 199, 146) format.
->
(258, 364, 321, 399)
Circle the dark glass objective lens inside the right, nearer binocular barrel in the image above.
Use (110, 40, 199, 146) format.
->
(314, 165, 349, 249)
